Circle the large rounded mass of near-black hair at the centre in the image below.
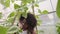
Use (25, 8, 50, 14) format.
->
(26, 13, 37, 29)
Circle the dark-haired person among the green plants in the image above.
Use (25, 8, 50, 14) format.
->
(19, 13, 37, 34)
